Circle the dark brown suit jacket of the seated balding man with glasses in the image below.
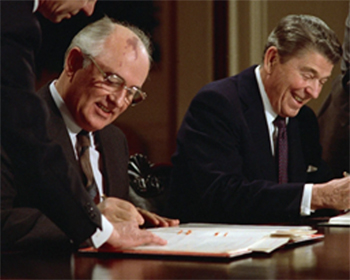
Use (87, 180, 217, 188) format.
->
(1, 85, 129, 248)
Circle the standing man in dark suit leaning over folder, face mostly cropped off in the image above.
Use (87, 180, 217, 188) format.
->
(1, 0, 165, 253)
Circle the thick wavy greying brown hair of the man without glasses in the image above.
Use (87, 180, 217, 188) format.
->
(264, 15, 342, 65)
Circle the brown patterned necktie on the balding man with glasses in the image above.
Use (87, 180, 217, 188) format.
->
(77, 130, 100, 204)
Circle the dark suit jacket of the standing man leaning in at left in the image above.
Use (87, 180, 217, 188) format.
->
(1, 1, 101, 248)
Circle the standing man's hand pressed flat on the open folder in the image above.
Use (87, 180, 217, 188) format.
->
(101, 222, 167, 250)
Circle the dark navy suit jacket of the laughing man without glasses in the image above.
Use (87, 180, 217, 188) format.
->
(166, 66, 329, 223)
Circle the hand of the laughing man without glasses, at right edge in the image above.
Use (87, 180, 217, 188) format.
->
(311, 176, 350, 210)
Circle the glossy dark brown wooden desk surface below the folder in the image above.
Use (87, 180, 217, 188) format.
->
(1, 227, 350, 279)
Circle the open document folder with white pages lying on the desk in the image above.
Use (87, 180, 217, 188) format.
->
(80, 224, 323, 258)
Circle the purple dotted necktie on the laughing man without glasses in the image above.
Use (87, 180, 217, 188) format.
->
(273, 116, 288, 184)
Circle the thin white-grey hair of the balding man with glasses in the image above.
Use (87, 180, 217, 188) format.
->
(65, 16, 152, 67)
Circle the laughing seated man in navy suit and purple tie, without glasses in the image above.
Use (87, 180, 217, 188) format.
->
(168, 15, 350, 223)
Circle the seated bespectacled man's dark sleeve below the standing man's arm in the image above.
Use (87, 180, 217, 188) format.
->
(0, 145, 70, 251)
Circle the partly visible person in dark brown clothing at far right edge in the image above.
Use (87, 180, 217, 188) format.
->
(318, 12, 350, 178)
